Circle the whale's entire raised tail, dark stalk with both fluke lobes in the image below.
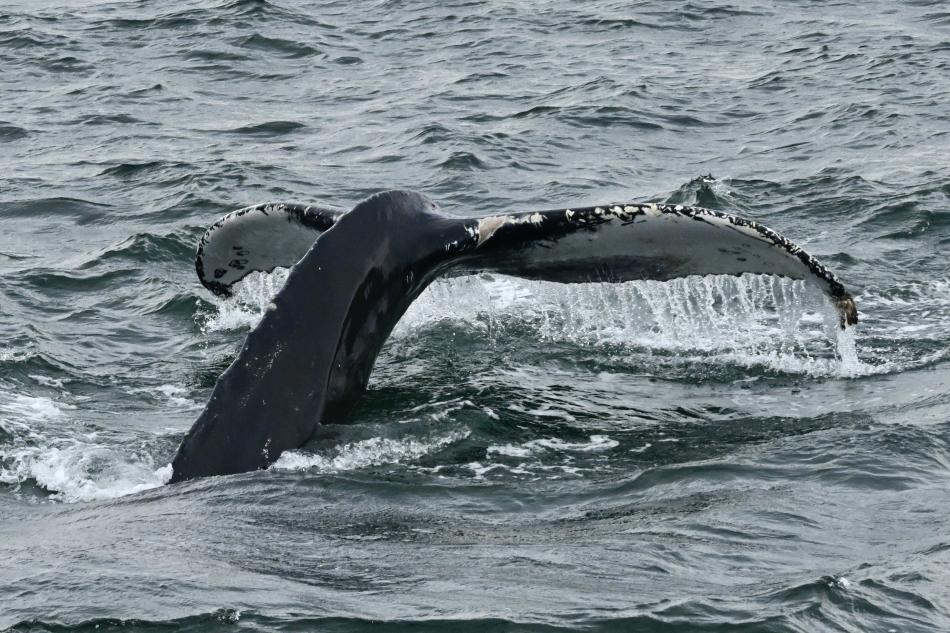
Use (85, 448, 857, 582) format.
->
(171, 191, 857, 482)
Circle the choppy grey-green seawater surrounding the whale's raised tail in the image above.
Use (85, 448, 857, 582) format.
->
(0, 0, 950, 633)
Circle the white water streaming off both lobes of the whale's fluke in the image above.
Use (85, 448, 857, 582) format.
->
(205, 271, 872, 377)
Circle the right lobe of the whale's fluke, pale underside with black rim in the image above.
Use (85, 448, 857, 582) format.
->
(463, 204, 857, 326)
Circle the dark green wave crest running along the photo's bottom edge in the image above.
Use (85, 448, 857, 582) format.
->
(7, 592, 944, 633)
